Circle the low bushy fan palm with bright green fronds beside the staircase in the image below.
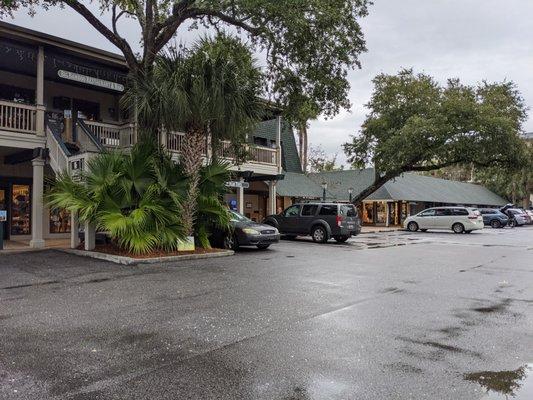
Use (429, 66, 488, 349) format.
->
(46, 144, 185, 254)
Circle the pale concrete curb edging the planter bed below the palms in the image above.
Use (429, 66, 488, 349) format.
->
(56, 249, 235, 265)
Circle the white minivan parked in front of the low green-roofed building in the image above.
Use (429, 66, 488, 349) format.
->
(404, 207, 484, 233)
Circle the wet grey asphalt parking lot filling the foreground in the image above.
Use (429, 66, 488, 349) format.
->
(0, 227, 533, 400)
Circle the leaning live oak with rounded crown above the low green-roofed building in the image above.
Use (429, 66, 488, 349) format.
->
(344, 69, 526, 203)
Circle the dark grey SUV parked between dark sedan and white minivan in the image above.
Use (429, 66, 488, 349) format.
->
(263, 203, 361, 243)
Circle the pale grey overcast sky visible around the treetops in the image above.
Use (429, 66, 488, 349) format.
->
(10, 0, 533, 163)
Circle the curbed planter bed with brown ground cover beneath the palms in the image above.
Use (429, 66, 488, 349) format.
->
(58, 244, 234, 265)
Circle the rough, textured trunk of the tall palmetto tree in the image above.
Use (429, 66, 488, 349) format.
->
(180, 129, 205, 236)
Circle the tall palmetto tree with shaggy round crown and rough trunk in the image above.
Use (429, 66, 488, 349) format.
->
(126, 35, 263, 235)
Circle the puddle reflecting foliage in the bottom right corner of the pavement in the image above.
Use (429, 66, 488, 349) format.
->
(464, 364, 533, 400)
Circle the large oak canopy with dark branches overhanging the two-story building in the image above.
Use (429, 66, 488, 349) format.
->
(0, 0, 370, 120)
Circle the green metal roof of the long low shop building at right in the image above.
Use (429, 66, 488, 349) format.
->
(310, 168, 507, 206)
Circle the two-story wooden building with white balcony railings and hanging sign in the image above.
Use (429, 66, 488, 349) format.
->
(0, 21, 283, 248)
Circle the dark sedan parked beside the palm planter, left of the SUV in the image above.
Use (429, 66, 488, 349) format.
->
(210, 210, 280, 250)
